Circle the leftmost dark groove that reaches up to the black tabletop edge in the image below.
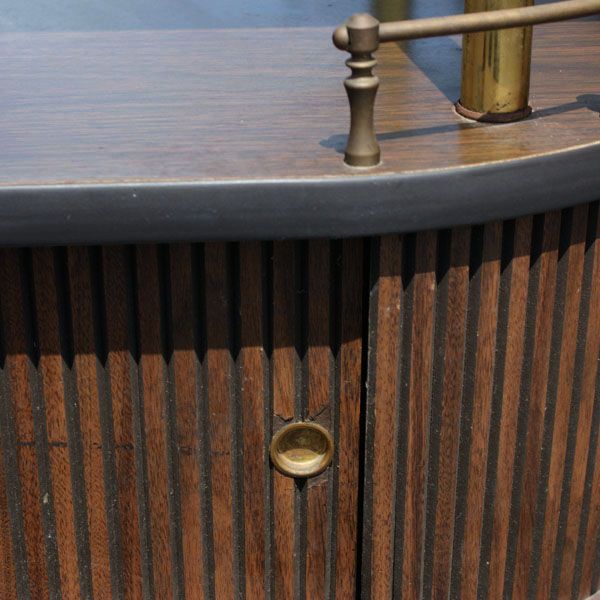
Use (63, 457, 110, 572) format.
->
(19, 250, 61, 600)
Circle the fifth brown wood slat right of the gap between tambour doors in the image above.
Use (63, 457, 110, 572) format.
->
(487, 217, 532, 598)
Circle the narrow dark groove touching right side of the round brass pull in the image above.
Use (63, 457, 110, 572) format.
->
(325, 240, 342, 600)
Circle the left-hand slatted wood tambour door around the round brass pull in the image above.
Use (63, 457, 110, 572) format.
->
(0, 241, 364, 600)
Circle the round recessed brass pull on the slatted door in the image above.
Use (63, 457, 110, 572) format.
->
(271, 423, 333, 477)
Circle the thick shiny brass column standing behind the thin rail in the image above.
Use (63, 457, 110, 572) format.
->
(456, 0, 533, 123)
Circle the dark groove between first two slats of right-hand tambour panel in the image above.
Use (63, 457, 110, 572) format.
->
(392, 234, 416, 600)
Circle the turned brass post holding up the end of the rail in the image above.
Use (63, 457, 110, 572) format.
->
(333, 14, 381, 167)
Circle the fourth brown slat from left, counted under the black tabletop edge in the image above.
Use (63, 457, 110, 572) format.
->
(102, 247, 145, 600)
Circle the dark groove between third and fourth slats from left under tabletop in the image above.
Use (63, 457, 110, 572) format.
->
(89, 247, 124, 600)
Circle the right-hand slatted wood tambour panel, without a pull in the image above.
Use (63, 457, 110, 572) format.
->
(361, 204, 600, 600)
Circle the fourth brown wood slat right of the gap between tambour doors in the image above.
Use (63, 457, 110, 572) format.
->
(460, 223, 502, 600)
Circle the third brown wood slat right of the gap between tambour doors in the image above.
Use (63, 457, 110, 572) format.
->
(431, 228, 471, 600)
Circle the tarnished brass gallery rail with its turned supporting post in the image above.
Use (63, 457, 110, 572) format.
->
(333, 0, 600, 167)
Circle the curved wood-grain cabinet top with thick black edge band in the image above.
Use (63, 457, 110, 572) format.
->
(0, 21, 600, 245)
